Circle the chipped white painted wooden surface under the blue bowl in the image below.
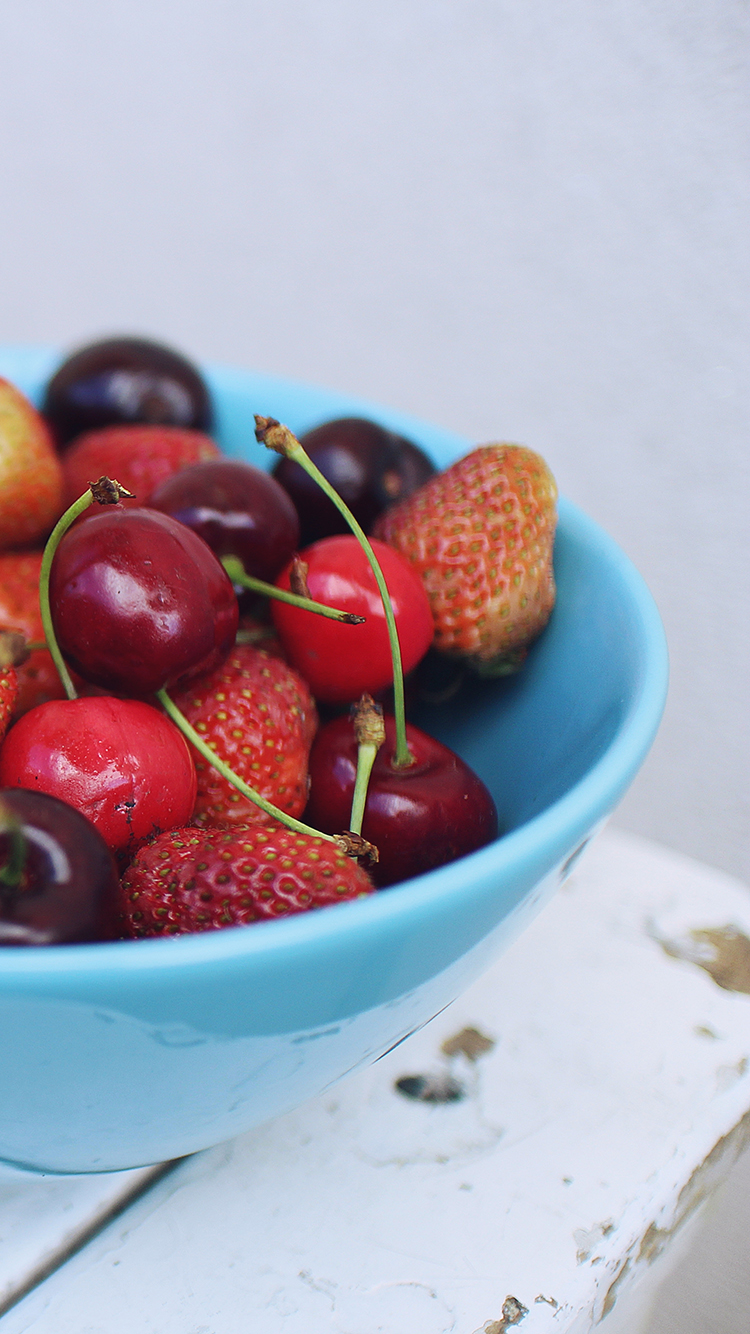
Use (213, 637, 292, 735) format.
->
(0, 831, 750, 1334)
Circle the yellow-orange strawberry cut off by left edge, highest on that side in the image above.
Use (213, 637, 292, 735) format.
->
(0, 379, 63, 551)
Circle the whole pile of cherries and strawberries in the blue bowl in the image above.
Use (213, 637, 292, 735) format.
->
(0, 339, 556, 944)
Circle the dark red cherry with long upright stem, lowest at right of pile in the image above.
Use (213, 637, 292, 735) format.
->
(304, 716, 498, 887)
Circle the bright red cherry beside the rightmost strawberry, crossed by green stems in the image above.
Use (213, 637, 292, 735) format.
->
(272, 536, 434, 703)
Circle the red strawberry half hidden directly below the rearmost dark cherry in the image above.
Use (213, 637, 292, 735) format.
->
(63, 426, 220, 512)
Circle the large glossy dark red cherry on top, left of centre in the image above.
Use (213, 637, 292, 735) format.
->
(49, 506, 238, 695)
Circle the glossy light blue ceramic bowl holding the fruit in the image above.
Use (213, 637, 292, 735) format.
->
(0, 350, 667, 1173)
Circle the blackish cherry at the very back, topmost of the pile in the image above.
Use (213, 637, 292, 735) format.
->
(41, 338, 214, 448)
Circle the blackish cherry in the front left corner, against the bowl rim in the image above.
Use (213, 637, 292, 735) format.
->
(0, 788, 119, 944)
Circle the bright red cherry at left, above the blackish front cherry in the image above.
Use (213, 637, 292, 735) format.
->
(0, 695, 196, 855)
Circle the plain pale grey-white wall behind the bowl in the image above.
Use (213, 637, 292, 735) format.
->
(0, 0, 750, 1334)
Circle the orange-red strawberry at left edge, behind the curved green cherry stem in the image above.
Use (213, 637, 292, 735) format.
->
(0, 551, 65, 716)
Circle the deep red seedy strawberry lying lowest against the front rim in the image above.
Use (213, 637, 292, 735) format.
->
(121, 822, 374, 936)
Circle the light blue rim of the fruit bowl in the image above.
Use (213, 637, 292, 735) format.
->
(0, 347, 669, 986)
